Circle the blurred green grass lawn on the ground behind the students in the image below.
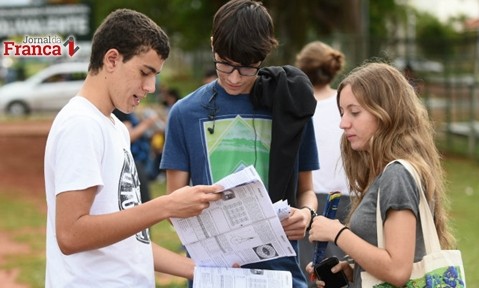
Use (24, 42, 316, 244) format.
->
(0, 157, 479, 288)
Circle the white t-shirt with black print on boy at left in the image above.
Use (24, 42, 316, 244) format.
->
(45, 96, 155, 288)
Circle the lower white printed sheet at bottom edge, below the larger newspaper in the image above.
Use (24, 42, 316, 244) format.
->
(193, 267, 293, 288)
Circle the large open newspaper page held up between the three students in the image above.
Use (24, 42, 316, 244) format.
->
(171, 166, 296, 267)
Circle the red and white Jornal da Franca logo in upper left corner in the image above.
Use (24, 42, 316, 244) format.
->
(3, 35, 80, 57)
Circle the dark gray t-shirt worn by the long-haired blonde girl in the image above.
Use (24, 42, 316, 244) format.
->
(350, 162, 425, 287)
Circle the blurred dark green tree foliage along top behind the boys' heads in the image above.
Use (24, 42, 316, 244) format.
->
(83, 0, 412, 64)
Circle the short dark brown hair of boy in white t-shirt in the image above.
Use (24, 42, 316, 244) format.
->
(88, 9, 170, 72)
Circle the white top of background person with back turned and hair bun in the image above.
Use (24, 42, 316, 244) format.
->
(313, 91, 349, 195)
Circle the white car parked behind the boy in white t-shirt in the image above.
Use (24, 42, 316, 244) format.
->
(0, 62, 88, 116)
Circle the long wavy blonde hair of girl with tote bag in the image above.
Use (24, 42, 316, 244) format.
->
(337, 63, 455, 249)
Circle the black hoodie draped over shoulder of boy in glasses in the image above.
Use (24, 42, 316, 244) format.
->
(251, 65, 316, 207)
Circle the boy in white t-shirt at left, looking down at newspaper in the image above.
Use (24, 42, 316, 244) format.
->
(44, 9, 222, 288)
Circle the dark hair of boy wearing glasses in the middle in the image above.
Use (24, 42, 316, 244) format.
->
(212, 0, 278, 65)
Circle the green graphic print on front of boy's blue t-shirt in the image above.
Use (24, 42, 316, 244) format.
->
(203, 116, 271, 187)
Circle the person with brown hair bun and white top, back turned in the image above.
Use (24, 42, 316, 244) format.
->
(295, 41, 350, 284)
